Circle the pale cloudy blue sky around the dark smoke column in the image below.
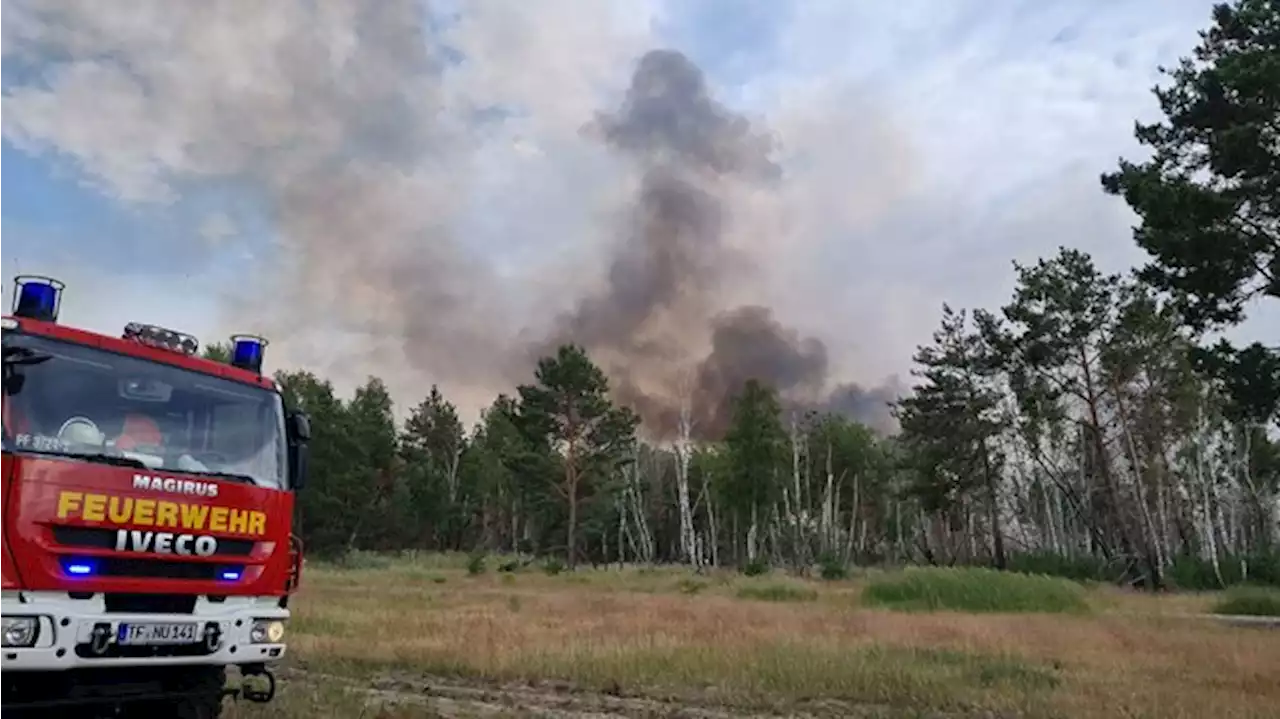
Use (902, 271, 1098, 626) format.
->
(0, 0, 1249, 409)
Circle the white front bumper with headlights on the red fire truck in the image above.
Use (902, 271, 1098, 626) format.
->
(0, 592, 289, 672)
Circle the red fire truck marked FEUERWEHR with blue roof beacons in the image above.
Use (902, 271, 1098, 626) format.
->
(0, 276, 311, 719)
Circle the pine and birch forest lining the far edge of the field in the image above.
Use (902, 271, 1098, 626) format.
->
(206, 0, 1280, 589)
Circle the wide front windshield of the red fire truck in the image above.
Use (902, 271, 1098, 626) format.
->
(0, 334, 287, 489)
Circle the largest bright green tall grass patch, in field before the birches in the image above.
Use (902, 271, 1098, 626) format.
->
(863, 568, 1089, 613)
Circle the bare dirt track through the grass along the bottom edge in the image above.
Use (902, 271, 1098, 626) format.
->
(282, 669, 977, 719)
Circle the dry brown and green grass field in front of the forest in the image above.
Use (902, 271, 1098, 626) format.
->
(228, 557, 1280, 719)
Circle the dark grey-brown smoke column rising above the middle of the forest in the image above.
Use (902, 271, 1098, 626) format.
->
(541, 50, 901, 439)
